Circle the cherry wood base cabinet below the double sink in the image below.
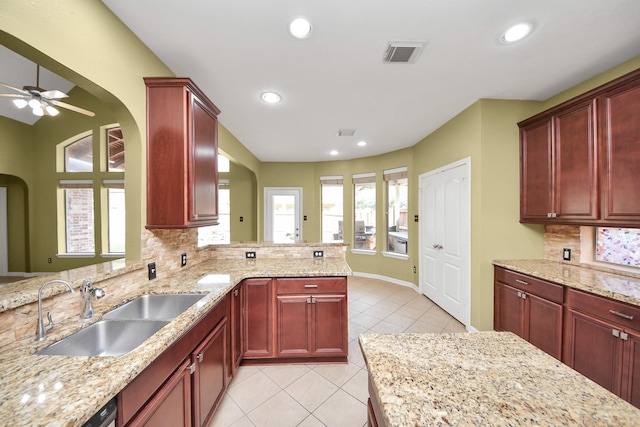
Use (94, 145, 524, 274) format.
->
(117, 295, 231, 427)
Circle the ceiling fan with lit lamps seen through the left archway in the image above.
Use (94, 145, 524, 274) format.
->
(0, 64, 95, 117)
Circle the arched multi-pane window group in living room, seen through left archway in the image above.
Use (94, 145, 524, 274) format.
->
(58, 125, 125, 256)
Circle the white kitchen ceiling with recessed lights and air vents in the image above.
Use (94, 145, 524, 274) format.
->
(0, 0, 640, 162)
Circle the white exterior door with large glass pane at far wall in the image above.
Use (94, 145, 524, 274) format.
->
(264, 187, 302, 243)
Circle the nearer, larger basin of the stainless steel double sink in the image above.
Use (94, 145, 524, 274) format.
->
(36, 320, 169, 356)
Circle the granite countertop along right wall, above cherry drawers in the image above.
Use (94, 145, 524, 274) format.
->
(493, 259, 640, 306)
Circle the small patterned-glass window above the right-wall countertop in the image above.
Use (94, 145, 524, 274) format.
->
(595, 227, 640, 267)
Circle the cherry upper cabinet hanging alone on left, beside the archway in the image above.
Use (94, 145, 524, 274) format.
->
(144, 77, 220, 228)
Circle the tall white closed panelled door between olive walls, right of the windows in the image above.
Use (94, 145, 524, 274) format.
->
(419, 159, 471, 326)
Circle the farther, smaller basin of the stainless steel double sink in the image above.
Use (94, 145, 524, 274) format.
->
(102, 294, 204, 320)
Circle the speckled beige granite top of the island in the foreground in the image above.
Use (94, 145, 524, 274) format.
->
(359, 332, 640, 427)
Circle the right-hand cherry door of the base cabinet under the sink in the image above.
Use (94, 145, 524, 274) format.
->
(191, 317, 229, 427)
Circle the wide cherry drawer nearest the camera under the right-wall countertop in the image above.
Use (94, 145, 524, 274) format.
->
(567, 289, 640, 331)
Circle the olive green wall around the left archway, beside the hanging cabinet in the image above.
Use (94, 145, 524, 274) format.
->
(0, 0, 173, 261)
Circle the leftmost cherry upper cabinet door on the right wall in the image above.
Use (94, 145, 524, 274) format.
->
(520, 119, 553, 223)
